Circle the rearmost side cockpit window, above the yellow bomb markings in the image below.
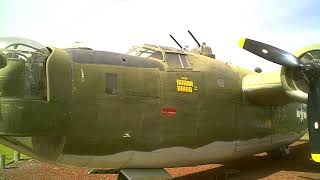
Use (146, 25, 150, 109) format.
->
(166, 53, 190, 68)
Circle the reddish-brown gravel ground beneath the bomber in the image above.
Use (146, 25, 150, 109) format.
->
(0, 141, 320, 180)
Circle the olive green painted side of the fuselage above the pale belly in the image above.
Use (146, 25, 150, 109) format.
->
(0, 42, 306, 168)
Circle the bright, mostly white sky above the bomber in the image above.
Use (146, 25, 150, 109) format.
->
(0, 0, 320, 71)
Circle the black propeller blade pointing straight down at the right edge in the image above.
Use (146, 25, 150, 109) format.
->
(307, 79, 320, 162)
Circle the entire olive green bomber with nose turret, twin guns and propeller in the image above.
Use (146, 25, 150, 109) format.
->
(0, 33, 320, 179)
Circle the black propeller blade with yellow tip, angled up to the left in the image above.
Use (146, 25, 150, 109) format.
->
(239, 38, 303, 68)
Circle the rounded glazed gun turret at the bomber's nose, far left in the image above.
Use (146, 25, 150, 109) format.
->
(0, 37, 50, 99)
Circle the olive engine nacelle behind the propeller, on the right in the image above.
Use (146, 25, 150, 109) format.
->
(242, 44, 320, 105)
